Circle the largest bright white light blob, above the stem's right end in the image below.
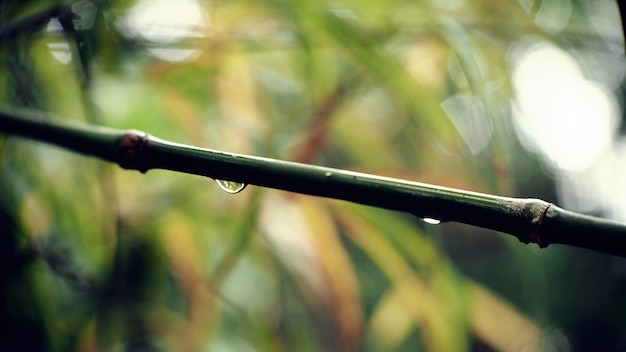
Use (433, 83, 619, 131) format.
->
(512, 41, 618, 171)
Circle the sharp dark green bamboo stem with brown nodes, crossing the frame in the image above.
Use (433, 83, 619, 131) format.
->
(0, 108, 626, 257)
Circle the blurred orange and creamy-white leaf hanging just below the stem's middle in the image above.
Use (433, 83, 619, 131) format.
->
(261, 193, 363, 351)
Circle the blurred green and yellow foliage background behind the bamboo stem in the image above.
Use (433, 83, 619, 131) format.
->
(0, 0, 626, 351)
